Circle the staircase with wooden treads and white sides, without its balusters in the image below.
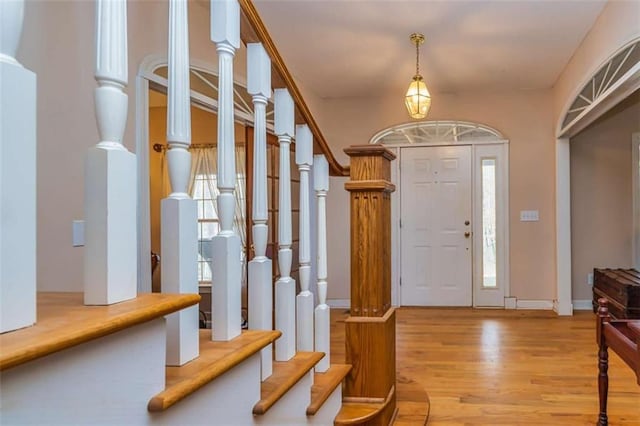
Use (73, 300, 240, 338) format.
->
(0, 293, 350, 425)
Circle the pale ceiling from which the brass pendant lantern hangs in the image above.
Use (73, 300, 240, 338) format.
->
(254, 0, 606, 98)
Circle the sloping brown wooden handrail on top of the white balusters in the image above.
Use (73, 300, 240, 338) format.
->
(239, 0, 349, 176)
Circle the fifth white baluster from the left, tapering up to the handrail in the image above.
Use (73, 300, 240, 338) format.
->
(247, 43, 273, 380)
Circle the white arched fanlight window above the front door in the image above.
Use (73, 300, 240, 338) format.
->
(369, 121, 504, 145)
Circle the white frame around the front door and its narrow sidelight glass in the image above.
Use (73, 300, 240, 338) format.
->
(387, 139, 511, 308)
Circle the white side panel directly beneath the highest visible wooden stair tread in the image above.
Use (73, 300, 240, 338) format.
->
(0, 318, 166, 425)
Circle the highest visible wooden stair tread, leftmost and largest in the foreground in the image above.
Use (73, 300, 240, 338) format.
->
(0, 292, 200, 371)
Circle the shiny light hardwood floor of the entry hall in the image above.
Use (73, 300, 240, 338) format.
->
(331, 308, 640, 426)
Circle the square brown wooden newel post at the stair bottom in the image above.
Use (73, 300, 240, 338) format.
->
(344, 145, 396, 425)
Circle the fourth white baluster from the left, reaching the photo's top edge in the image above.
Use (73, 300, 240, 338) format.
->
(211, 0, 242, 340)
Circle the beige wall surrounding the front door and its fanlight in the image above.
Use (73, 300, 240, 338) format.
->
(313, 90, 555, 300)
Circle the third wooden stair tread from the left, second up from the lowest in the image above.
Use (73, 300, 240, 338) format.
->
(253, 352, 324, 415)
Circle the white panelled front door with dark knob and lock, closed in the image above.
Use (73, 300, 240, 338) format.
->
(400, 146, 472, 306)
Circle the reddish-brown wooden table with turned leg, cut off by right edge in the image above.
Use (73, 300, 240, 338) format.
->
(596, 298, 640, 426)
